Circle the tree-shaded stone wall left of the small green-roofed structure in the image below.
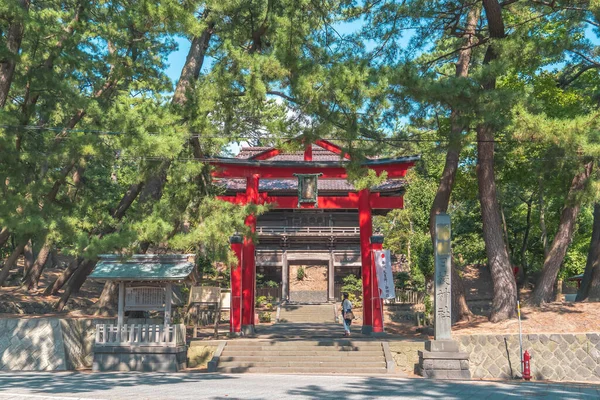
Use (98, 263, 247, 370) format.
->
(0, 318, 114, 371)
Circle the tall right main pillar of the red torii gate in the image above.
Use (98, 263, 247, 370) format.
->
(358, 189, 373, 334)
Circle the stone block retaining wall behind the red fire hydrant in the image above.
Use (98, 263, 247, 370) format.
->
(455, 333, 600, 382)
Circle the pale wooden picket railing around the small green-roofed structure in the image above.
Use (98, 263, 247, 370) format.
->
(96, 324, 185, 347)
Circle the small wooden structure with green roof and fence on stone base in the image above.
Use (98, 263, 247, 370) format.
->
(90, 254, 196, 372)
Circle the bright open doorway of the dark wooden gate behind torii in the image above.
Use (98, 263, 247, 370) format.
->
(289, 262, 329, 303)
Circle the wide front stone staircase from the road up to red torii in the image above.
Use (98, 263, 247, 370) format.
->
(216, 338, 393, 375)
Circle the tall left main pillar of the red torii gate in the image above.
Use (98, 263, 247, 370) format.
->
(242, 174, 259, 335)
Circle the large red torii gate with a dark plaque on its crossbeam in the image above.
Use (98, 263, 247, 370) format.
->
(206, 140, 419, 334)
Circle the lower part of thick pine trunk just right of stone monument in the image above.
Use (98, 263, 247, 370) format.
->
(477, 124, 517, 322)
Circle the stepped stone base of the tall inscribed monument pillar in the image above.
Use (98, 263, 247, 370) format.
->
(417, 340, 471, 380)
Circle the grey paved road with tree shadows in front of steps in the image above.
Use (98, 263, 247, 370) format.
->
(0, 372, 600, 400)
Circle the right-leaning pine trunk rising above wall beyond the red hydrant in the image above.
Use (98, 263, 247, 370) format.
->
(531, 161, 594, 306)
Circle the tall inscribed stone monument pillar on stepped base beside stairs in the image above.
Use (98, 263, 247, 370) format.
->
(418, 214, 471, 379)
